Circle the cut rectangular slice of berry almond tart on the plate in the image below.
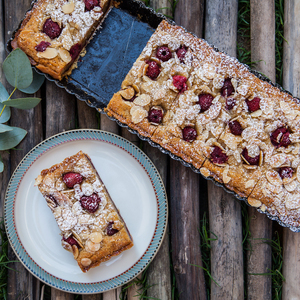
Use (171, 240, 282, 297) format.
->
(35, 151, 133, 272)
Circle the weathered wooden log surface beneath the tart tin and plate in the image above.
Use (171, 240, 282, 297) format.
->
(0, 0, 300, 300)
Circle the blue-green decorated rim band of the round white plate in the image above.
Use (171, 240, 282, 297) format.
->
(4, 129, 168, 294)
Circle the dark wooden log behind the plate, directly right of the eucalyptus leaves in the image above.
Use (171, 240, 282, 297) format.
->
(44, 81, 76, 300)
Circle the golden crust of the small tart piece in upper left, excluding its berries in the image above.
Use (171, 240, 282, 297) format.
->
(11, 0, 110, 80)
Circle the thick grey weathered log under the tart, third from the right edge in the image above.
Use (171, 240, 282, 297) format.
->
(204, 0, 244, 299)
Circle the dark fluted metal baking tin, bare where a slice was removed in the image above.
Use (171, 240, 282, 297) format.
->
(7, 0, 300, 232)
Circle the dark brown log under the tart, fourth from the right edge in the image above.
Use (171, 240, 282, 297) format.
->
(169, 0, 206, 299)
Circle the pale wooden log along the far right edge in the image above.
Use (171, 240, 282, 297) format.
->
(282, 0, 300, 300)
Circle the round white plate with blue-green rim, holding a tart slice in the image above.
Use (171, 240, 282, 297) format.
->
(4, 129, 168, 294)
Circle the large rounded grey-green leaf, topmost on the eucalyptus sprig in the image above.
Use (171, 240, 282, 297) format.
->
(2, 48, 33, 89)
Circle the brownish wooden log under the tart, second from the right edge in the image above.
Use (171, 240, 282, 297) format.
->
(246, 0, 276, 300)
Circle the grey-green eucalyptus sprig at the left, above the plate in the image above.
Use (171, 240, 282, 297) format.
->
(0, 49, 45, 172)
